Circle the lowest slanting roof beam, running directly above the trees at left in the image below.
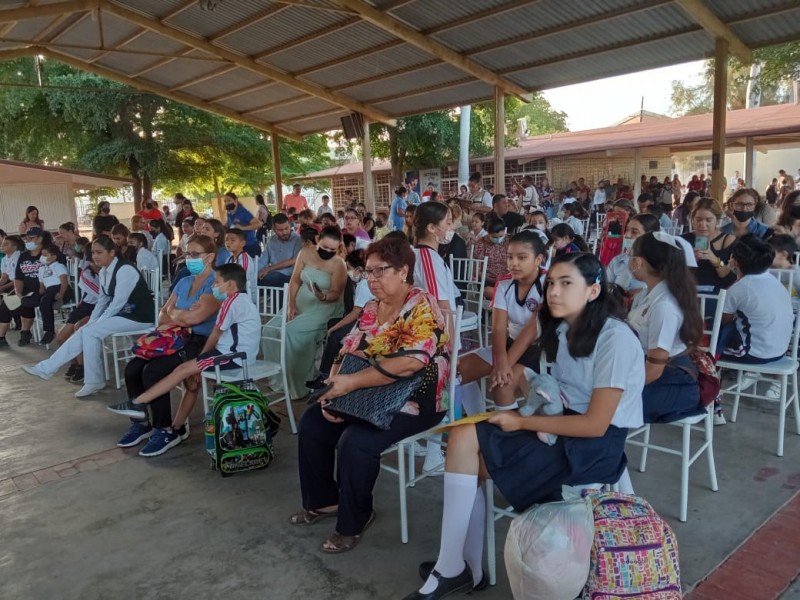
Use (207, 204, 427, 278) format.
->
(39, 48, 303, 141)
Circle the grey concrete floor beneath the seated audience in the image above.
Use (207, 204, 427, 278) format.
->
(0, 340, 800, 600)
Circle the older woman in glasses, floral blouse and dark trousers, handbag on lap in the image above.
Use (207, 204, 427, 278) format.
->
(289, 235, 451, 554)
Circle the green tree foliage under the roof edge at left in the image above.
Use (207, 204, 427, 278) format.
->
(0, 58, 329, 210)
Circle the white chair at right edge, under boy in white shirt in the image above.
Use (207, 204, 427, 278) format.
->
(717, 314, 800, 456)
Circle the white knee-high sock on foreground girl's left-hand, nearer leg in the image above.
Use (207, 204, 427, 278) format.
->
(420, 473, 478, 594)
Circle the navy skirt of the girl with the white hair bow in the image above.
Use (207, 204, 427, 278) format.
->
(642, 356, 705, 423)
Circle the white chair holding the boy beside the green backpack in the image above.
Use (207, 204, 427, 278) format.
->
(201, 283, 297, 433)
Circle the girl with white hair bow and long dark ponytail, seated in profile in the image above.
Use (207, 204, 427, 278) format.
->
(628, 231, 704, 423)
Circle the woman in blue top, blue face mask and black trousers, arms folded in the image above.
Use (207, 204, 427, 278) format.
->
(111, 235, 220, 456)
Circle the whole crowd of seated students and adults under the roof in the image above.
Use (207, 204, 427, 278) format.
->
(0, 173, 800, 599)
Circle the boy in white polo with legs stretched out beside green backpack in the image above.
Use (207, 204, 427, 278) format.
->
(108, 264, 261, 456)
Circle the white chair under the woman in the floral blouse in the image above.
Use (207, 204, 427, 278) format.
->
(381, 307, 463, 544)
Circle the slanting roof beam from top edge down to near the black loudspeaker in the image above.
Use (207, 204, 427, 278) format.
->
(104, 4, 397, 126)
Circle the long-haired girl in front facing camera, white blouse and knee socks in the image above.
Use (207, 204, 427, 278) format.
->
(406, 253, 644, 600)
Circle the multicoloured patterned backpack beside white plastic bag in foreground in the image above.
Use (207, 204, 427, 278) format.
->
(583, 490, 682, 600)
